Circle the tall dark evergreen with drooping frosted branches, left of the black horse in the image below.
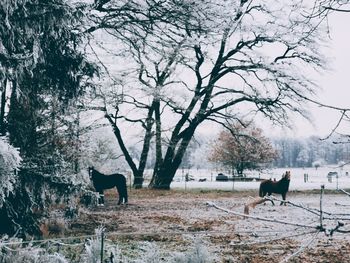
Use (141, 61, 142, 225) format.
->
(0, 0, 95, 238)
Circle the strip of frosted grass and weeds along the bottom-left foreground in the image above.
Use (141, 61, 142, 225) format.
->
(0, 233, 214, 263)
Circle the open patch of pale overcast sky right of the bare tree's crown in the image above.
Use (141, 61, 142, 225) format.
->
(271, 10, 350, 137)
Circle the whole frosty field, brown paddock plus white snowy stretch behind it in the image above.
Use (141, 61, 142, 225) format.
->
(11, 167, 350, 263)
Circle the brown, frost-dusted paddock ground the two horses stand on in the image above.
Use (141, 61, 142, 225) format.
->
(61, 189, 350, 263)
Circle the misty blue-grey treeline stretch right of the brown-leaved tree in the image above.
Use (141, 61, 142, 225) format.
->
(271, 136, 350, 167)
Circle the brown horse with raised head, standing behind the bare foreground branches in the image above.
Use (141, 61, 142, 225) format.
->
(259, 171, 290, 205)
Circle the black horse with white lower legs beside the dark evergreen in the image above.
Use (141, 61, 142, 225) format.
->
(89, 167, 128, 205)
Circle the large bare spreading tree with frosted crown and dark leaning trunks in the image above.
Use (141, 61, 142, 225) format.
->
(86, 0, 330, 189)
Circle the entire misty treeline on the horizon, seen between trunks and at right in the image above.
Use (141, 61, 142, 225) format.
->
(144, 136, 350, 169)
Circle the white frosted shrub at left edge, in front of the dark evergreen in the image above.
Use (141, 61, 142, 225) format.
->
(0, 137, 22, 207)
